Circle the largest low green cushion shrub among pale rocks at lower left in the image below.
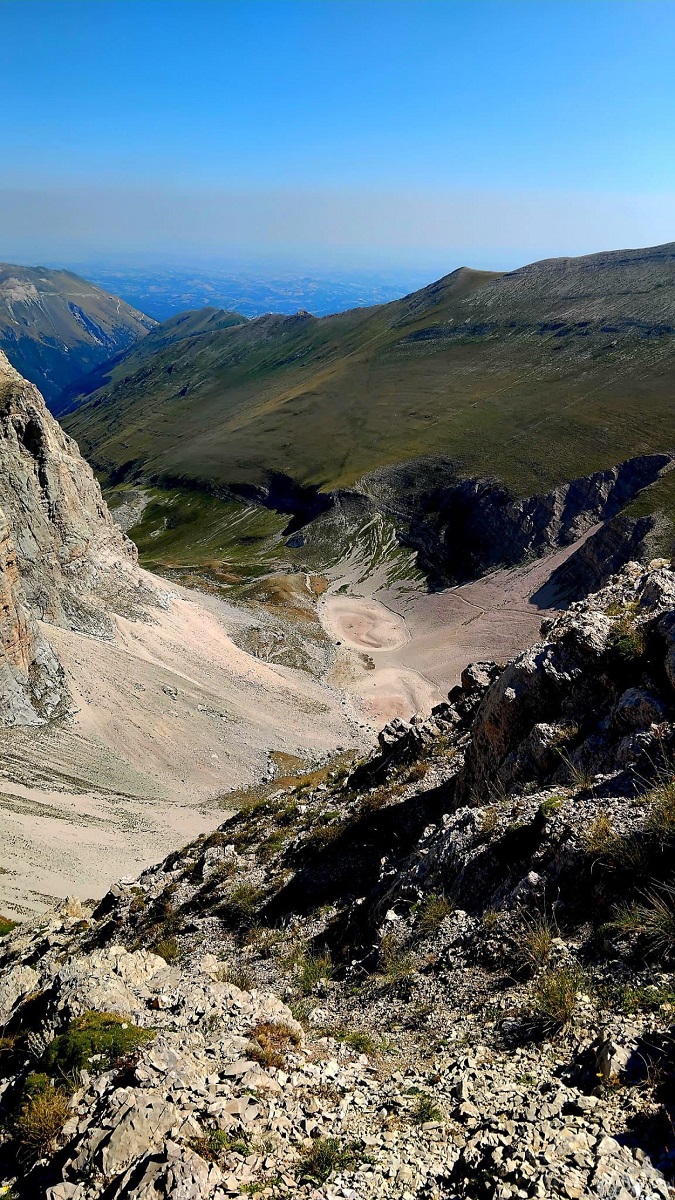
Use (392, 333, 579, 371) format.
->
(43, 1012, 155, 1079)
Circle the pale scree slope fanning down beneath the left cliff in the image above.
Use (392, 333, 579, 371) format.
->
(0, 577, 372, 914)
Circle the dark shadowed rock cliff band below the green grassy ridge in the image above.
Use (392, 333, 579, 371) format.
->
(294, 454, 673, 600)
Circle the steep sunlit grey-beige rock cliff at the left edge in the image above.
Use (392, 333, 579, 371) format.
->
(0, 352, 149, 725)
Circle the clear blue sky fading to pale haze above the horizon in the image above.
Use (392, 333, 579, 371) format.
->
(0, 0, 675, 269)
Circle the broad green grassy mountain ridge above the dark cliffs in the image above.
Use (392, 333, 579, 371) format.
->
(60, 244, 675, 508)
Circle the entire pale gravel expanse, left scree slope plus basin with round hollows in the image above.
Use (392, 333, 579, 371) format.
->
(0, 530, 592, 916)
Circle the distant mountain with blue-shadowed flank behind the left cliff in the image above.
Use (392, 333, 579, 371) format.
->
(0, 263, 156, 406)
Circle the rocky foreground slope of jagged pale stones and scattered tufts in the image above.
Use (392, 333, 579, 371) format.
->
(0, 563, 675, 1200)
